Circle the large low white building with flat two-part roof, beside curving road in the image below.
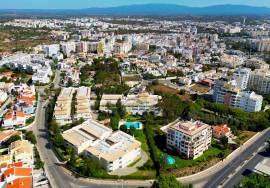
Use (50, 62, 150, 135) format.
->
(63, 120, 141, 171)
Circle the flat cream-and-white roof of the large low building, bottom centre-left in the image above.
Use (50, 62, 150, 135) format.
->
(63, 120, 141, 161)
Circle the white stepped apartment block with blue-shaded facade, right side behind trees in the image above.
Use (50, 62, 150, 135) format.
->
(213, 78, 263, 112)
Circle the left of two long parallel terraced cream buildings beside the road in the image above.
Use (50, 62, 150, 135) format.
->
(54, 87, 75, 125)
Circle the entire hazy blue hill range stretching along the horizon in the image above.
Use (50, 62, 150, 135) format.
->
(0, 4, 270, 16)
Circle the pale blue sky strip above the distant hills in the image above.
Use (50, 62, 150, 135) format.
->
(0, 0, 270, 9)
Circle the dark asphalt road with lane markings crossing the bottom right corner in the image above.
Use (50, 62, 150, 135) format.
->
(204, 130, 270, 188)
